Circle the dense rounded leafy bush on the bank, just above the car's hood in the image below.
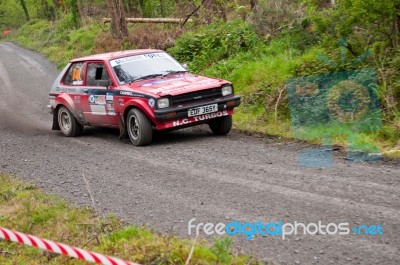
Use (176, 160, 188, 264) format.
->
(169, 20, 262, 71)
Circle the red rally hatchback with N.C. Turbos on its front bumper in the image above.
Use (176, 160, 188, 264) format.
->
(48, 50, 240, 146)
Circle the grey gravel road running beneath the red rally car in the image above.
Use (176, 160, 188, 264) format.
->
(0, 43, 400, 264)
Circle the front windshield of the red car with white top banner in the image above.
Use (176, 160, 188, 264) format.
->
(110, 52, 187, 84)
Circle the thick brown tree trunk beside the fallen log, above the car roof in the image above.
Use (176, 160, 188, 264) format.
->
(107, 0, 129, 39)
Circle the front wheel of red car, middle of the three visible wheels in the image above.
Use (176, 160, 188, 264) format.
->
(126, 109, 153, 146)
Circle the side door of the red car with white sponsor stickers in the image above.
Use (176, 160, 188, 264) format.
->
(82, 61, 118, 126)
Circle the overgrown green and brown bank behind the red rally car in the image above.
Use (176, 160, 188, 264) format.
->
(0, 0, 400, 158)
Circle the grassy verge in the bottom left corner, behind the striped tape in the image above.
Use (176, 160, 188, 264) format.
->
(0, 174, 261, 265)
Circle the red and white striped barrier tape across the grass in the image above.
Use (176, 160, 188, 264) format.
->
(0, 227, 140, 265)
